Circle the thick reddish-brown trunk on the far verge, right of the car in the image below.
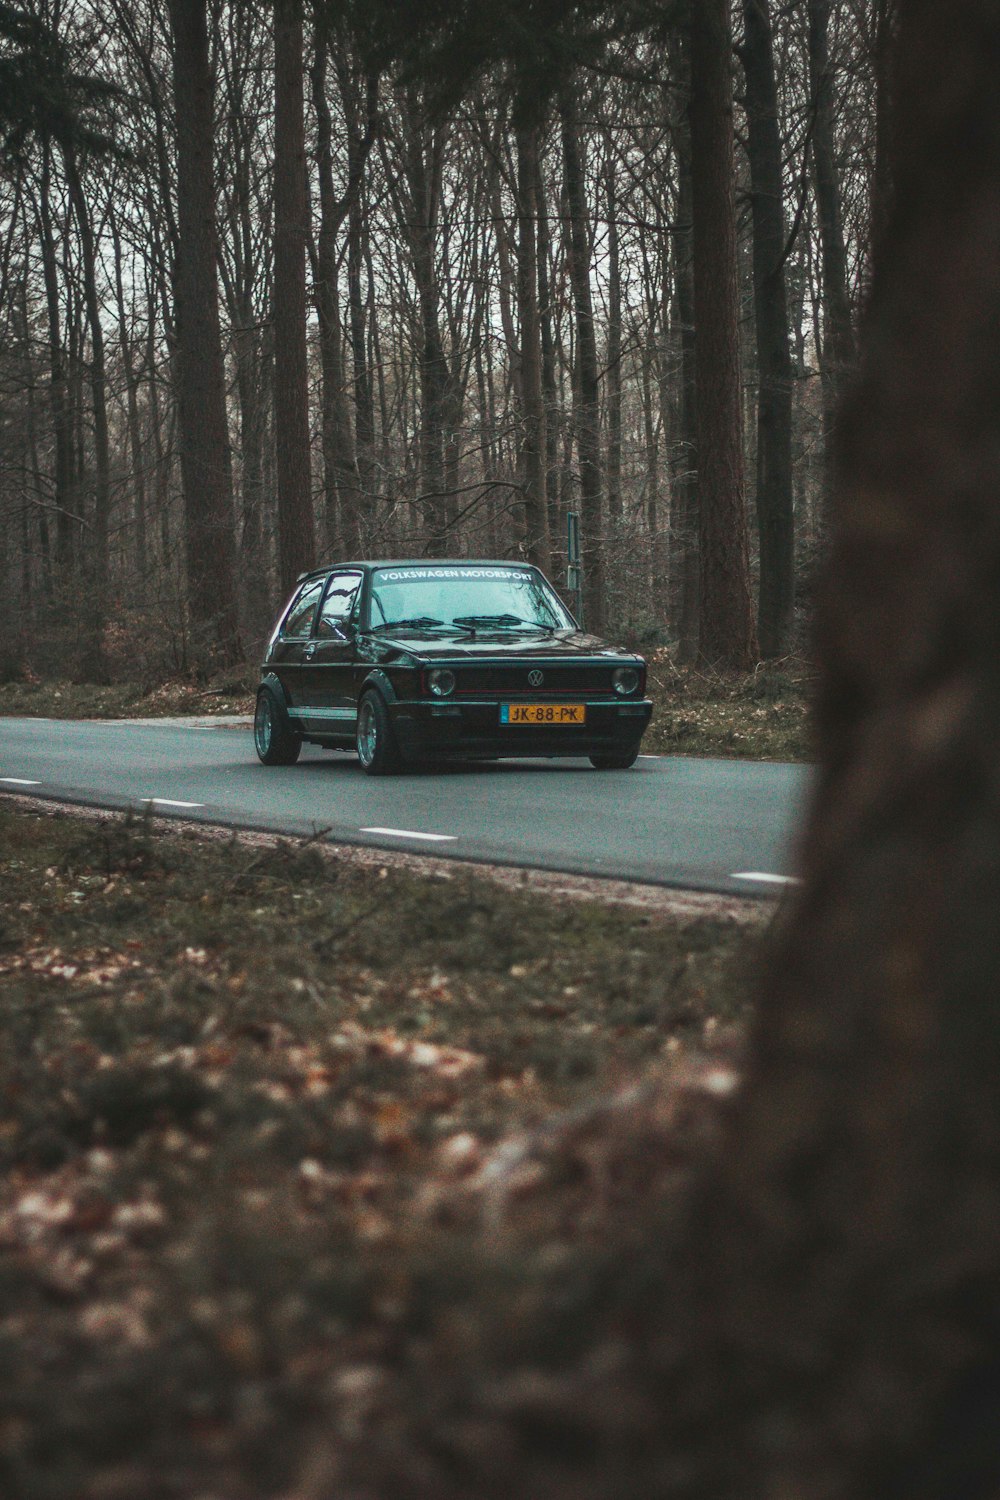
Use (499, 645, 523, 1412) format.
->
(691, 0, 757, 671)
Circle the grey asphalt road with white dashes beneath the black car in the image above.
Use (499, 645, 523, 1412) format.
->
(0, 719, 808, 896)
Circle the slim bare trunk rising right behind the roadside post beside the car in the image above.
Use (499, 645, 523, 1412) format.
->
(559, 86, 607, 635)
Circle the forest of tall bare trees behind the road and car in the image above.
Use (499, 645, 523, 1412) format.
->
(0, 0, 895, 684)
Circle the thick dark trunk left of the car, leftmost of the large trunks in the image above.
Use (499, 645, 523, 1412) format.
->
(168, 0, 240, 669)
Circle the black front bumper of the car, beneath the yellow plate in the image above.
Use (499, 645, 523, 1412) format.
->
(388, 698, 652, 761)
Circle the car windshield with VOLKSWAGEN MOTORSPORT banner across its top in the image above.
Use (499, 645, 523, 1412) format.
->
(372, 566, 573, 632)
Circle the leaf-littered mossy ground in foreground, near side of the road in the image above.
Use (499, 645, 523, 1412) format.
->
(0, 800, 775, 1500)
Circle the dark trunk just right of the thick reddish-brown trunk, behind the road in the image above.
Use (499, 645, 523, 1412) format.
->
(741, 0, 795, 659)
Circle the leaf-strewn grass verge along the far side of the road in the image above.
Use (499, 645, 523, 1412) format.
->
(0, 650, 813, 761)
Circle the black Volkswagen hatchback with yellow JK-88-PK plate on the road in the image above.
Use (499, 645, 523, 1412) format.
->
(253, 561, 652, 776)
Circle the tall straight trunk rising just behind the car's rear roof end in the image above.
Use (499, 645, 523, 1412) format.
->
(271, 0, 316, 594)
